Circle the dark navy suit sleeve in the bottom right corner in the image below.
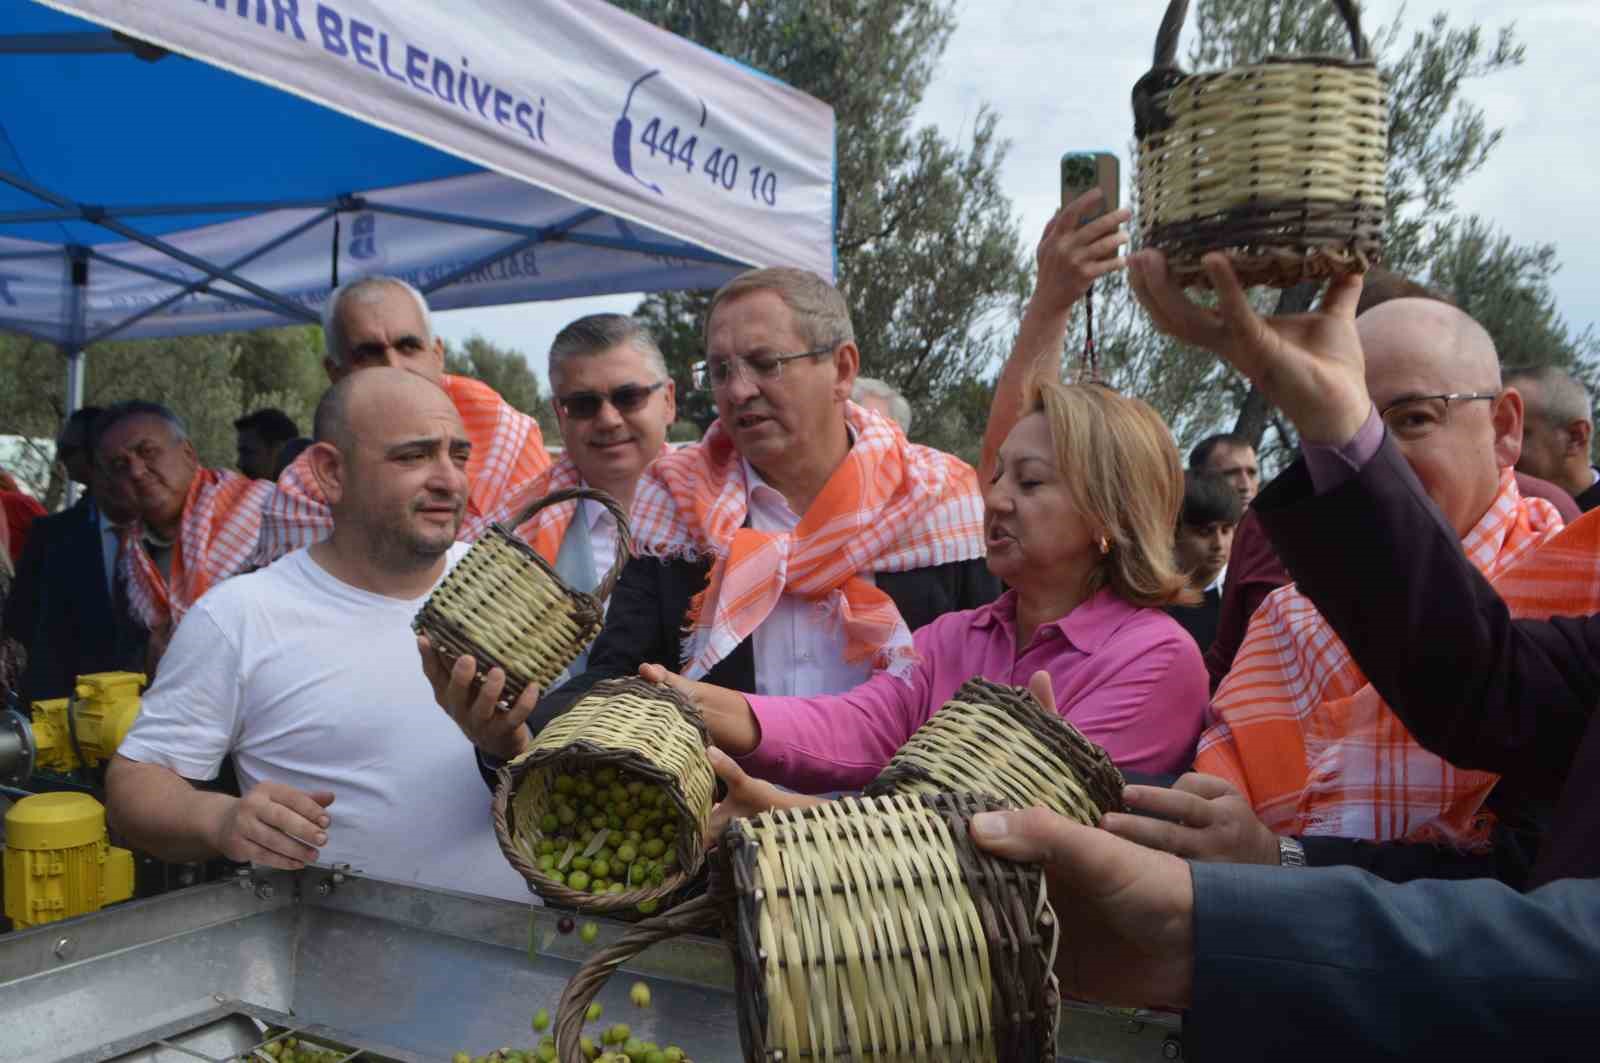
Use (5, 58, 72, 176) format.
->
(1182, 863, 1600, 1063)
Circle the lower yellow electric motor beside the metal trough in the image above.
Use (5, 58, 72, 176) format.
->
(5, 794, 133, 930)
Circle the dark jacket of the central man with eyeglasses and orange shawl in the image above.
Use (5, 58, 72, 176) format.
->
(528, 557, 1000, 735)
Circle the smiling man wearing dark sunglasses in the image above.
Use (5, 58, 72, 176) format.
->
(419, 314, 677, 685)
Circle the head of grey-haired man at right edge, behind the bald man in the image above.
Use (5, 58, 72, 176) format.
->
(1506, 365, 1600, 512)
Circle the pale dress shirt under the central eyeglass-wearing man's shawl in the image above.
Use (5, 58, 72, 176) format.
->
(744, 461, 874, 698)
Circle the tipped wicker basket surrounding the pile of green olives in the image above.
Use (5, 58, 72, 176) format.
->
(493, 677, 715, 914)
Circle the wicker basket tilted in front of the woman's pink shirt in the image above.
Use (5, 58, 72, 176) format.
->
(866, 679, 1123, 826)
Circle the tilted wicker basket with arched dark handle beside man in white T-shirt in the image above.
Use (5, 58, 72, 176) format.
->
(411, 487, 634, 704)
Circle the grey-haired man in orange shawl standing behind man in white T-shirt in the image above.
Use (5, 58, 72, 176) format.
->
(254, 275, 550, 565)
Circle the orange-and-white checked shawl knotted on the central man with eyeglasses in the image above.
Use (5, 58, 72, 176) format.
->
(632, 403, 984, 679)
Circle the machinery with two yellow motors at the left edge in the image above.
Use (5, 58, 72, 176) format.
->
(0, 672, 219, 929)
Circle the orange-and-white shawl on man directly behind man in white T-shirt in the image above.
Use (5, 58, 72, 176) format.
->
(256, 375, 550, 565)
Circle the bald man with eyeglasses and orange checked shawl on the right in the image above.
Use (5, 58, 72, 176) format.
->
(1195, 298, 1562, 850)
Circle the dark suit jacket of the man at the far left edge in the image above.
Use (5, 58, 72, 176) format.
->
(5, 501, 146, 706)
